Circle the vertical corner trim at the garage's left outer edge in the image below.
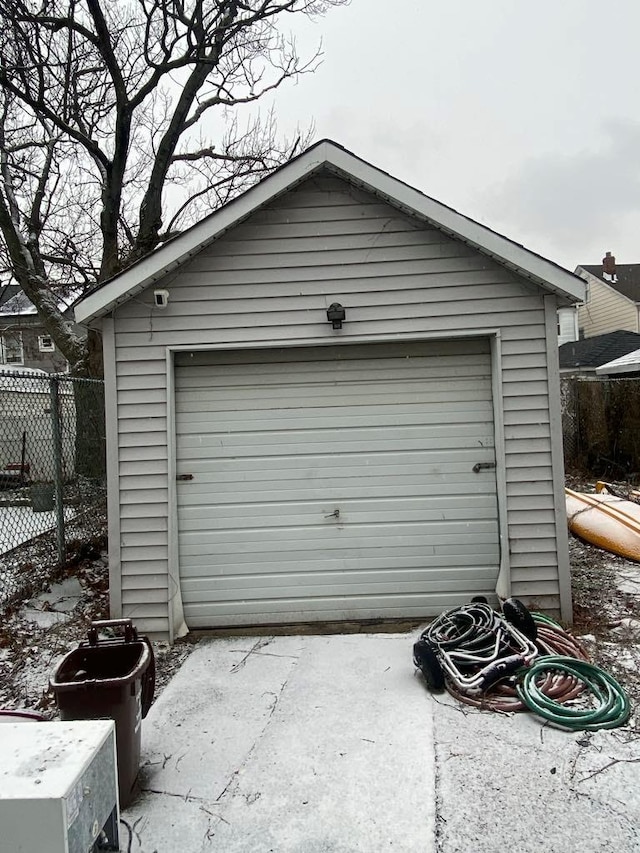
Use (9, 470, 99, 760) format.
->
(101, 315, 122, 619)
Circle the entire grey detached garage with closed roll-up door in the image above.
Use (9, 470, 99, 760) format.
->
(76, 136, 584, 639)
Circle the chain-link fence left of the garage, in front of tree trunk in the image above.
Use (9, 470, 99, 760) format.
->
(0, 368, 107, 610)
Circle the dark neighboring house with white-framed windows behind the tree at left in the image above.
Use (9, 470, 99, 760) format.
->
(0, 286, 73, 373)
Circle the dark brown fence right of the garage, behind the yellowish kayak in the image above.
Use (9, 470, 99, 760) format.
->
(561, 377, 640, 482)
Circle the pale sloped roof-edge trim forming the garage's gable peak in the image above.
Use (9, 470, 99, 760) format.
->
(76, 139, 585, 323)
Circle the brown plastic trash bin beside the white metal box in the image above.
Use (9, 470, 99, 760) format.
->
(50, 619, 155, 808)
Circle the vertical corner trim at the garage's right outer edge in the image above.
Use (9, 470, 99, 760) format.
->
(543, 294, 573, 624)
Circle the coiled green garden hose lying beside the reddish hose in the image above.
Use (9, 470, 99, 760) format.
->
(516, 655, 631, 731)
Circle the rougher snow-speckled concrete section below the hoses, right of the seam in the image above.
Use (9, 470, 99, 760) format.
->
(432, 696, 640, 853)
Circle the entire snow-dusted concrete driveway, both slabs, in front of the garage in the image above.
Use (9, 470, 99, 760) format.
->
(122, 634, 640, 853)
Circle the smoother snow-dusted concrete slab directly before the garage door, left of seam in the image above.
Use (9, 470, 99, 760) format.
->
(123, 634, 435, 853)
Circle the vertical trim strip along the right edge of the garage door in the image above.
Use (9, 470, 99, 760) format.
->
(489, 330, 511, 599)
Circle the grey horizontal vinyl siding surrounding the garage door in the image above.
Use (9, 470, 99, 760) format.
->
(112, 175, 558, 632)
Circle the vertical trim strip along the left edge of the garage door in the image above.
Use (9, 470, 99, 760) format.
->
(166, 347, 189, 643)
